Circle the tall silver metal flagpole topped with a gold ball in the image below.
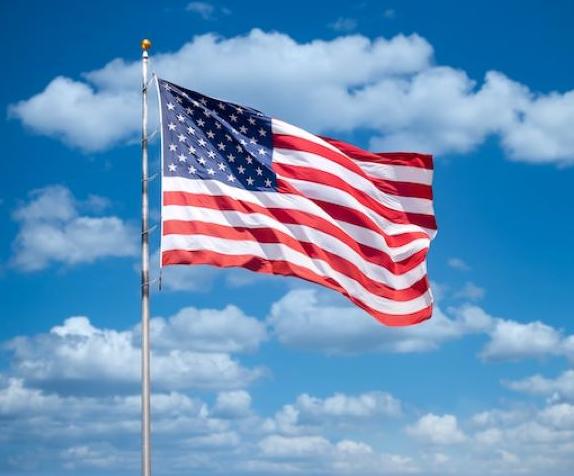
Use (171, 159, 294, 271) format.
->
(141, 40, 151, 476)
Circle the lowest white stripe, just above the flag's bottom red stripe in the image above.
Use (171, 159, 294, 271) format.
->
(162, 235, 432, 315)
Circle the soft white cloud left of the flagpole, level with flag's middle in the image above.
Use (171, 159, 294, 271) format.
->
(12, 185, 139, 271)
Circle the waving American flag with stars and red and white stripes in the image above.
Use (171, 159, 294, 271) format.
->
(158, 79, 436, 326)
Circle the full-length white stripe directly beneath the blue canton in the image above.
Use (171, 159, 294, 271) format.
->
(162, 177, 428, 251)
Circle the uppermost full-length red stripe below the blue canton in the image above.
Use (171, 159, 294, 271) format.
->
(163, 192, 428, 266)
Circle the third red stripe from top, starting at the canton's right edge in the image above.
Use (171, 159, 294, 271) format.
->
(273, 163, 436, 230)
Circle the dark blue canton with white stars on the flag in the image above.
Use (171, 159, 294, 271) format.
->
(158, 79, 276, 191)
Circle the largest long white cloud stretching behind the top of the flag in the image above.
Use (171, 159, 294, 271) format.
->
(9, 30, 574, 164)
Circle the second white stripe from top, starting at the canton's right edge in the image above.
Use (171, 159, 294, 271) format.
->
(273, 148, 433, 215)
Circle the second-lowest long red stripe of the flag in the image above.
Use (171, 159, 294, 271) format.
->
(163, 220, 428, 301)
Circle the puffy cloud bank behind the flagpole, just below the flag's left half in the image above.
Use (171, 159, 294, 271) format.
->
(4, 308, 263, 390)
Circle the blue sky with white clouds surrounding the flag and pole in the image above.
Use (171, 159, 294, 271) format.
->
(0, 1, 574, 475)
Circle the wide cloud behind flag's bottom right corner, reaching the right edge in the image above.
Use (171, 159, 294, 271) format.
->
(267, 288, 574, 361)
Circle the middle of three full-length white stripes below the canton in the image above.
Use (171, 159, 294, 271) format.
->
(163, 205, 432, 290)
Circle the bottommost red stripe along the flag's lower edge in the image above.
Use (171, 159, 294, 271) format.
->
(162, 250, 432, 326)
